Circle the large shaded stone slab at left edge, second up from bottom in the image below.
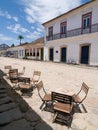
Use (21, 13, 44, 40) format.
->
(0, 108, 23, 125)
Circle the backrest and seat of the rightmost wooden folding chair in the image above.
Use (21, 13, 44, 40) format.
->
(73, 82, 89, 105)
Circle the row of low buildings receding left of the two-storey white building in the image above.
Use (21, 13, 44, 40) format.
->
(6, 38, 44, 60)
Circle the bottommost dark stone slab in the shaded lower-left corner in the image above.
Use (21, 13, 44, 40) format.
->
(0, 119, 33, 130)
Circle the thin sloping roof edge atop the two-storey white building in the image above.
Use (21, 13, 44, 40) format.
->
(42, 0, 96, 26)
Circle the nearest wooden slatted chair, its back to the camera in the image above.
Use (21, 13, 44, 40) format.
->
(52, 92, 73, 127)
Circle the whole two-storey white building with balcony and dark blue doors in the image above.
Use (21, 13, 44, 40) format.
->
(43, 0, 98, 66)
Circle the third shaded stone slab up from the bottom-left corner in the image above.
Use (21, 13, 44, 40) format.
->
(0, 102, 17, 113)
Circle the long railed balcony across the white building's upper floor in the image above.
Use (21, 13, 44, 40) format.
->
(46, 23, 98, 41)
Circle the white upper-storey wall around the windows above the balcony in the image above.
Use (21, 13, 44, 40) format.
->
(45, 2, 98, 36)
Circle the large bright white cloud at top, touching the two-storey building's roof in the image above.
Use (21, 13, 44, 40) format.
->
(21, 0, 81, 23)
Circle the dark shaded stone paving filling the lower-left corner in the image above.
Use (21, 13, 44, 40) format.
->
(0, 70, 52, 130)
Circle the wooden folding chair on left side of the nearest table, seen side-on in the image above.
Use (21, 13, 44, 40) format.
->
(36, 81, 51, 109)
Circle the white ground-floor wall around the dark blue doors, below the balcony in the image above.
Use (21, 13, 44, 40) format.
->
(44, 33, 98, 65)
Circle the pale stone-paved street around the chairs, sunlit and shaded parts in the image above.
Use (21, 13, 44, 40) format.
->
(0, 57, 98, 130)
